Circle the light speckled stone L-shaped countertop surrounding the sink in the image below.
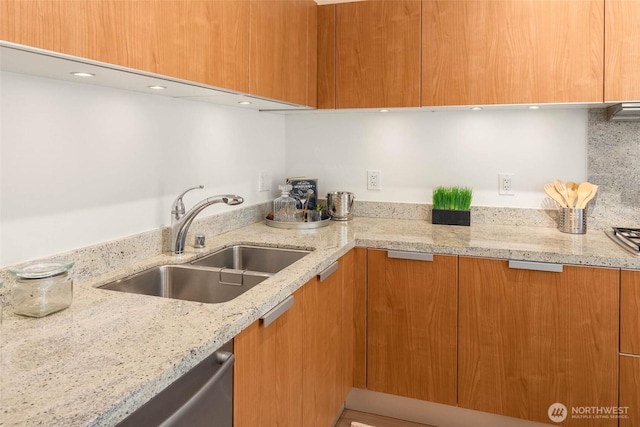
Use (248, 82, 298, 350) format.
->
(0, 218, 640, 427)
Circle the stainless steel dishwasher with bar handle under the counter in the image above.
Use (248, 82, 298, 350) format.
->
(118, 340, 235, 427)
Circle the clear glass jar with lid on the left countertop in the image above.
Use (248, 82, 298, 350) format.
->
(9, 261, 73, 317)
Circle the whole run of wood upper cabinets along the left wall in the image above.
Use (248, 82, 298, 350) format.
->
(0, 0, 317, 106)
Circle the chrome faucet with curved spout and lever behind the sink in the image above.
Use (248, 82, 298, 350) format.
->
(171, 185, 244, 255)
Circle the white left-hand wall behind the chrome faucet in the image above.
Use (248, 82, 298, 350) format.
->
(0, 72, 285, 266)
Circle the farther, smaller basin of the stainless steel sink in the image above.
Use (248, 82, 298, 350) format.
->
(191, 245, 309, 274)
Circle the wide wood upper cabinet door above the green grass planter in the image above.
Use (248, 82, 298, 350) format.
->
(422, 0, 604, 106)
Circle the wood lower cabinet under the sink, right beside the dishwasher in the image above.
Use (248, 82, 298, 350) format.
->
(234, 250, 364, 427)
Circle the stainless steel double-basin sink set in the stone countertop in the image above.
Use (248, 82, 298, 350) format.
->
(100, 245, 309, 303)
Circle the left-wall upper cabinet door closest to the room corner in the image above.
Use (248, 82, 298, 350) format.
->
(249, 0, 318, 106)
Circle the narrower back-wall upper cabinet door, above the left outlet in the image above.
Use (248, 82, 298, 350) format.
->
(332, 0, 420, 108)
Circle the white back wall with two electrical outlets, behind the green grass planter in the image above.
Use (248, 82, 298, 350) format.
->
(286, 109, 588, 208)
